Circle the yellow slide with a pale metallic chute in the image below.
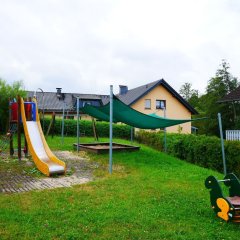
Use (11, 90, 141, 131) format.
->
(21, 98, 66, 176)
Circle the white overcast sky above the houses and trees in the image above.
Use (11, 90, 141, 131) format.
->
(0, 0, 240, 94)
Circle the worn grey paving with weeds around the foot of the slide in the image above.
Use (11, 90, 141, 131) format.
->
(0, 151, 98, 193)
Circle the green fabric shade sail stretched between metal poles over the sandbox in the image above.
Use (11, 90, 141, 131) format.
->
(81, 96, 203, 129)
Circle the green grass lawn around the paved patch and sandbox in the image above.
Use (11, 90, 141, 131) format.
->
(0, 138, 239, 240)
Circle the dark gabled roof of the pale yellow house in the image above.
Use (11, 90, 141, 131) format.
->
(117, 79, 198, 114)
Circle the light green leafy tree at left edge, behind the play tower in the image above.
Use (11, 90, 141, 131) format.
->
(0, 79, 26, 132)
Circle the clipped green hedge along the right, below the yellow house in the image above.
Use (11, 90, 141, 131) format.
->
(136, 131, 240, 175)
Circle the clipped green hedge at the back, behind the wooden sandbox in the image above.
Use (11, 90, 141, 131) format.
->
(40, 118, 131, 139)
